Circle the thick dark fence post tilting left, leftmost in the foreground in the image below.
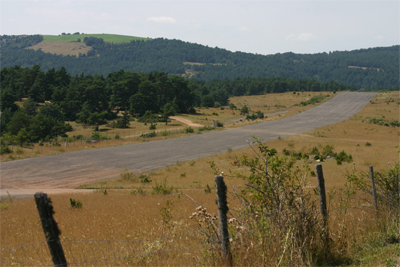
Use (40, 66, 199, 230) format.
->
(35, 192, 67, 266)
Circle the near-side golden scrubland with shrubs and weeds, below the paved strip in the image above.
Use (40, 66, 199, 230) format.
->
(0, 92, 400, 266)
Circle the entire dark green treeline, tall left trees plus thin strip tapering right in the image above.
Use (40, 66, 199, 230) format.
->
(0, 65, 355, 148)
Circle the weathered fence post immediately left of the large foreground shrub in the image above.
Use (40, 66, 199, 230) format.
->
(215, 175, 232, 266)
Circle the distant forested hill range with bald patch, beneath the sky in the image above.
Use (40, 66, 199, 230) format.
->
(0, 34, 400, 89)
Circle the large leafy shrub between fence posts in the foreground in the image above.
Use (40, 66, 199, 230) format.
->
(211, 139, 328, 266)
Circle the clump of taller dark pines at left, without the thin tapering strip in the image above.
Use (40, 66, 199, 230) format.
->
(0, 65, 195, 146)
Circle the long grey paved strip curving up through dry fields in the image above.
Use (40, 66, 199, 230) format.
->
(0, 92, 375, 197)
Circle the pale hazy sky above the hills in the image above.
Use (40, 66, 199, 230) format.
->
(0, 0, 400, 55)
